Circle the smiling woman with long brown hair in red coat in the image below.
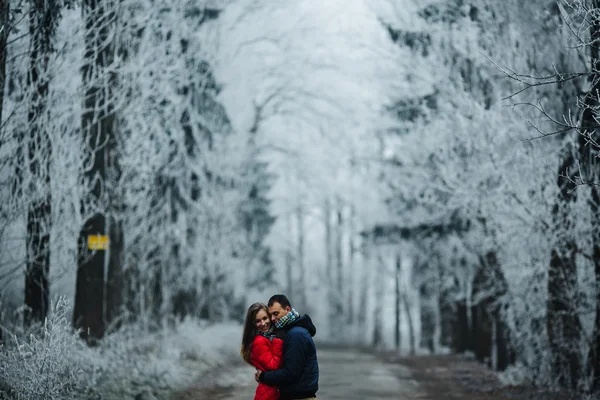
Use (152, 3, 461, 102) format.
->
(240, 303, 283, 400)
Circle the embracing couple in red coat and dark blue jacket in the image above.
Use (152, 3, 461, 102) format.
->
(240, 294, 319, 400)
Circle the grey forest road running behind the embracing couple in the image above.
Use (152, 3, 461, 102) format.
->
(171, 348, 581, 400)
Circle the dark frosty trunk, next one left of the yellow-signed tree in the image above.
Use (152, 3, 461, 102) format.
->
(25, 0, 57, 323)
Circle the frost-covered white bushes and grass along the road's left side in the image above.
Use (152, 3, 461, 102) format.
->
(0, 298, 242, 400)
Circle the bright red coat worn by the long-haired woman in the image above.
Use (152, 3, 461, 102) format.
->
(250, 335, 283, 400)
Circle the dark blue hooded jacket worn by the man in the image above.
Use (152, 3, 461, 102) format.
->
(260, 314, 319, 400)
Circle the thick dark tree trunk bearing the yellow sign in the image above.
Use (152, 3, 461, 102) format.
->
(73, 0, 119, 344)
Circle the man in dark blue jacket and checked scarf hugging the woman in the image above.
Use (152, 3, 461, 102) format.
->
(255, 294, 319, 400)
